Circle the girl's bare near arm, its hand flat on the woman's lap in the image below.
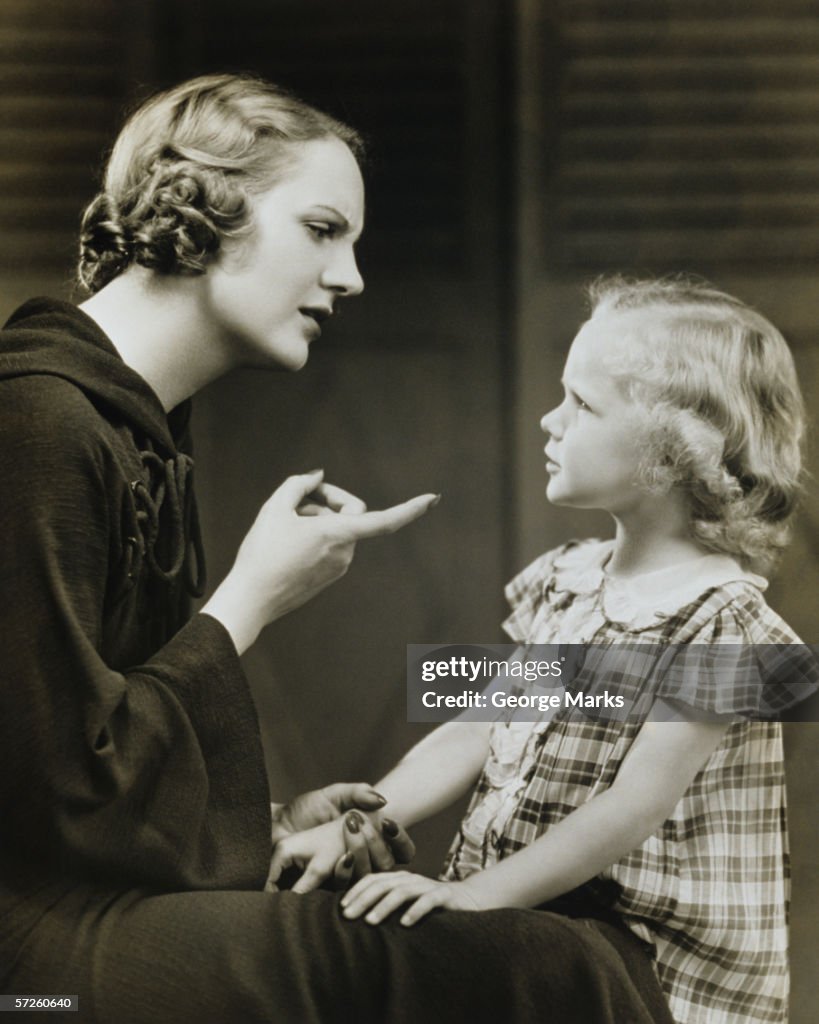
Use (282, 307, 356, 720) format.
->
(343, 720, 730, 925)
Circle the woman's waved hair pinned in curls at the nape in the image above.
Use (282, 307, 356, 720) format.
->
(78, 75, 362, 292)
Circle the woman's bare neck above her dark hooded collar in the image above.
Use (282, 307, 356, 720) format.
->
(80, 266, 232, 412)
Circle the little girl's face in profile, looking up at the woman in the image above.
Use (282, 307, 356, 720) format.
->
(541, 311, 648, 514)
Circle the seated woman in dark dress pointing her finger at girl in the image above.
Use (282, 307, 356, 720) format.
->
(0, 76, 671, 1024)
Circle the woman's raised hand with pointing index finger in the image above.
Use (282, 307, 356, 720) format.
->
(202, 470, 438, 653)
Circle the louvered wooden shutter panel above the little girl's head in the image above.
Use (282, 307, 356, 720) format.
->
(538, 0, 819, 271)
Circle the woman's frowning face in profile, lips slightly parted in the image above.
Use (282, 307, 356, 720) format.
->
(205, 138, 364, 370)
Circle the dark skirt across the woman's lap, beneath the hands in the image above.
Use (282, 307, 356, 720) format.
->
(8, 891, 671, 1024)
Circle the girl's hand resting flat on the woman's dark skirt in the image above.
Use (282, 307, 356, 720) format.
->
(341, 871, 485, 927)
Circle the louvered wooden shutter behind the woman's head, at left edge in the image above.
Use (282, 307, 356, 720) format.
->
(0, 0, 141, 276)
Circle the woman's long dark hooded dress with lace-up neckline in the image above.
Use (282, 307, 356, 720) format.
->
(0, 299, 670, 1024)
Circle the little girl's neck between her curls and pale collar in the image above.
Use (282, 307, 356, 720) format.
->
(606, 494, 708, 578)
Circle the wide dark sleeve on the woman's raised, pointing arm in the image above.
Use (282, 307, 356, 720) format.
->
(0, 395, 270, 888)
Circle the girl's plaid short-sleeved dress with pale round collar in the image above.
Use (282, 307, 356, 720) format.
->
(442, 541, 810, 1024)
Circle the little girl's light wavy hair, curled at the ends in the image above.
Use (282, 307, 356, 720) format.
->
(589, 276, 805, 572)
